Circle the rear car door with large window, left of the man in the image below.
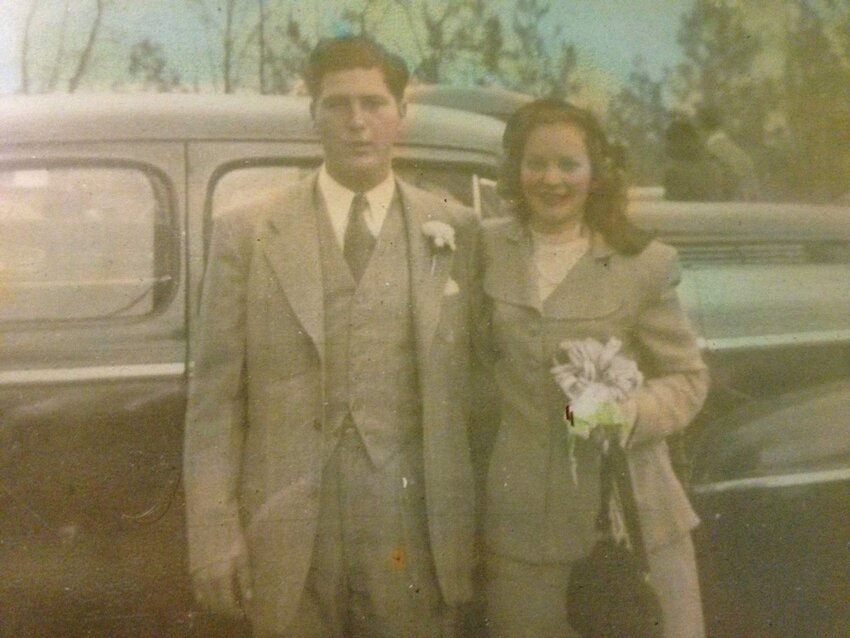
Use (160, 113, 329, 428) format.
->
(0, 141, 188, 635)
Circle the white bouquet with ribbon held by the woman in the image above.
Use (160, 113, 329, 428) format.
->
(551, 337, 643, 481)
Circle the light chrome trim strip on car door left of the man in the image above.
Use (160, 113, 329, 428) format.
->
(0, 362, 186, 386)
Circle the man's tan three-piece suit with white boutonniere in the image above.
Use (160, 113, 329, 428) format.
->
(184, 175, 478, 635)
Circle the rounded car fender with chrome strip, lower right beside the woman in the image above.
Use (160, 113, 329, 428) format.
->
(691, 379, 850, 638)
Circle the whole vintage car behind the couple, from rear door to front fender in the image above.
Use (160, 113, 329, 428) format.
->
(0, 95, 850, 637)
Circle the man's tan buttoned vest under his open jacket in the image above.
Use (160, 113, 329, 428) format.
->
(319, 194, 421, 466)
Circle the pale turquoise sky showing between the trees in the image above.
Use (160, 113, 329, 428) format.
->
(0, 0, 692, 100)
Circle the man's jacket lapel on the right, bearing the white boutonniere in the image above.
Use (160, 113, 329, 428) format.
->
(397, 181, 454, 368)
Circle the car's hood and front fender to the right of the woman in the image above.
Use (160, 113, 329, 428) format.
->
(632, 200, 850, 638)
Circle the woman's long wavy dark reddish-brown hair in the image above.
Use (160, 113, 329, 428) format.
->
(498, 98, 651, 255)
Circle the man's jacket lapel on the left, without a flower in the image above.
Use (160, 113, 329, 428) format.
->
(260, 175, 325, 356)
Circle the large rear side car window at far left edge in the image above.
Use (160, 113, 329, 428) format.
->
(0, 165, 176, 322)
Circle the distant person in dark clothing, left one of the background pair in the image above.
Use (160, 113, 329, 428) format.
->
(664, 118, 736, 202)
